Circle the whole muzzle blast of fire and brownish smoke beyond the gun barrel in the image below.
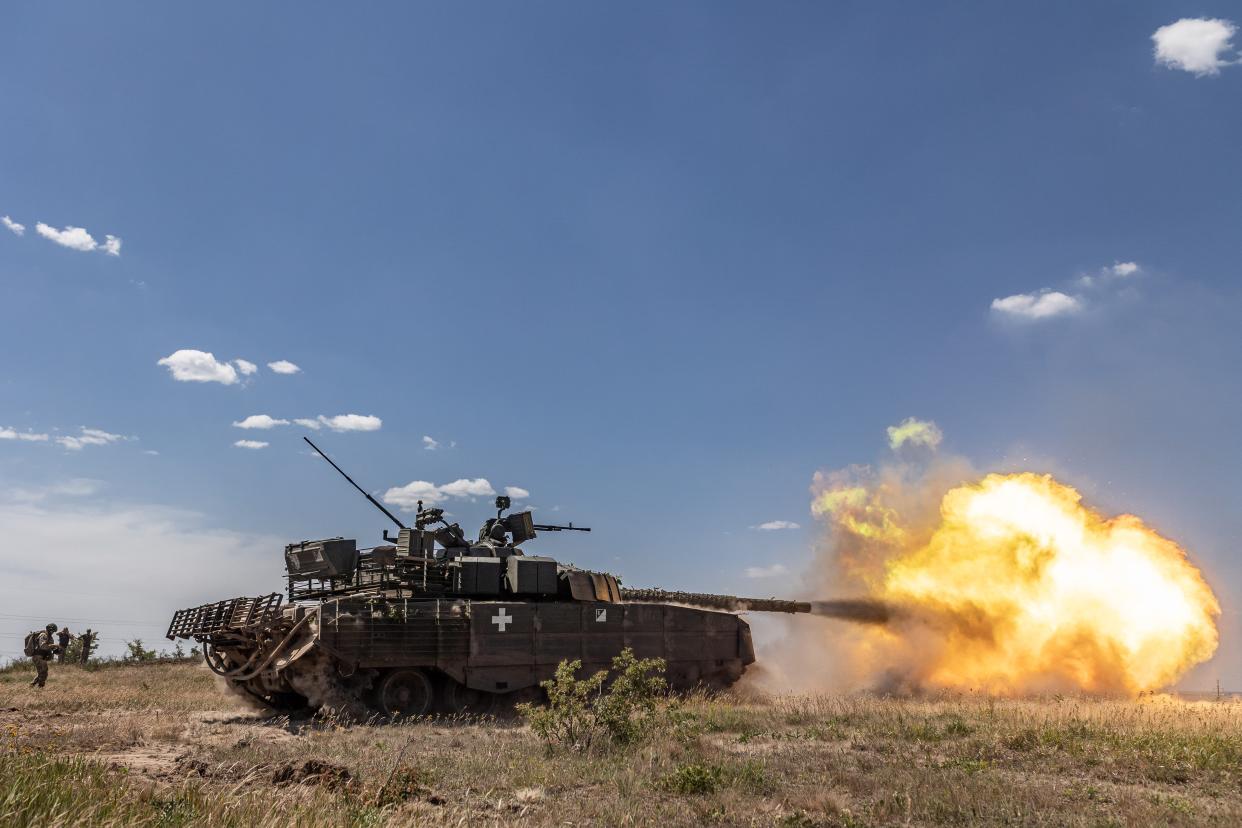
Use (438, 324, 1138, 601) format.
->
(754, 418, 1220, 695)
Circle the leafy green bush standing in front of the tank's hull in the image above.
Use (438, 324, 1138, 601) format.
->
(518, 647, 667, 751)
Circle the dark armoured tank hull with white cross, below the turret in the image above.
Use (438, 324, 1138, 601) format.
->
(184, 596, 755, 715)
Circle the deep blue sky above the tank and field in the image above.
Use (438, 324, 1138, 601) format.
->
(0, 2, 1242, 688)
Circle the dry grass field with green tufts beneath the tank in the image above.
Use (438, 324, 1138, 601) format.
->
(0, 664, 1242, 826)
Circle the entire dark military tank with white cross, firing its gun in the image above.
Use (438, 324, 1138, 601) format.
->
(168, 439, 811, 718)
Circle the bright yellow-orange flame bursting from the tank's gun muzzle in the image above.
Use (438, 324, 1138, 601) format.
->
(812, 473, 1220, 694)
